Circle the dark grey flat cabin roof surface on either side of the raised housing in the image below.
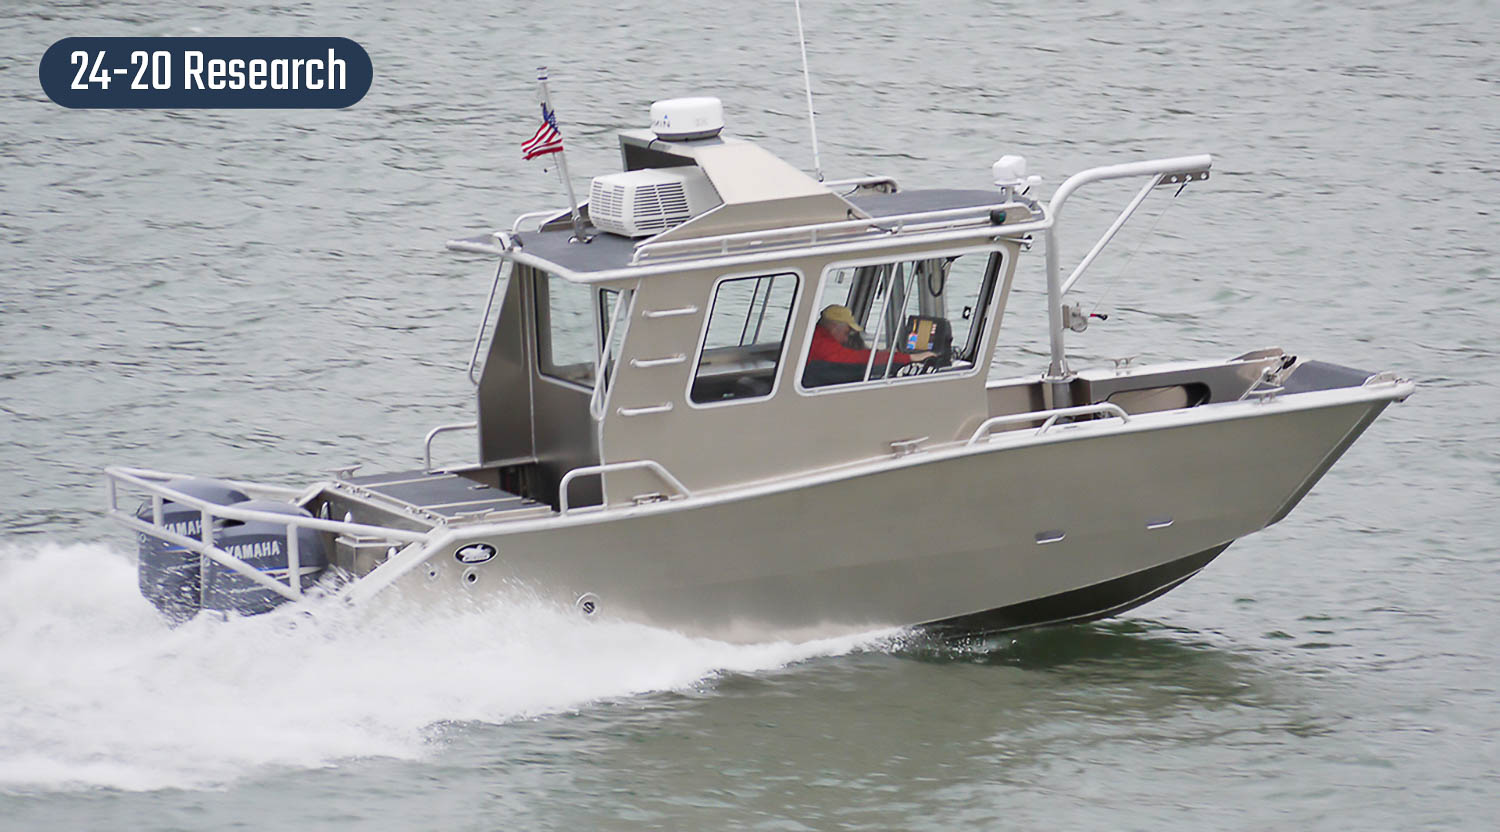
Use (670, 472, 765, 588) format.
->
(498, 189, 1001, 274)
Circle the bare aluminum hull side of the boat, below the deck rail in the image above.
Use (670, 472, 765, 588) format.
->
(393, 382, 1410, 640)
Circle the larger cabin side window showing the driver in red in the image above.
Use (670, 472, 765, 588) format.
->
(801, 252, 1001, 388)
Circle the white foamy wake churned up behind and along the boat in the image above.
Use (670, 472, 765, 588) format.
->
(0, 543, 879, 793)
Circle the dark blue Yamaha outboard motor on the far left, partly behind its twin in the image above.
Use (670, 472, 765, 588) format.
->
(135, 478, 251, 624)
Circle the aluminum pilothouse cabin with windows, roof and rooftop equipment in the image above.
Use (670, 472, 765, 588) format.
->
(452, 99, 1041, 507)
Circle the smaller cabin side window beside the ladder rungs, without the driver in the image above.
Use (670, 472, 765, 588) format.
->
(690, 273, 797, 405)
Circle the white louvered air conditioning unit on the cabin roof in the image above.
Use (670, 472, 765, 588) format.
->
(588, 165, 723, 237)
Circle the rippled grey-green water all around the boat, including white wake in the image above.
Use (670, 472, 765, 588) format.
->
(0, 0, 1500, 831)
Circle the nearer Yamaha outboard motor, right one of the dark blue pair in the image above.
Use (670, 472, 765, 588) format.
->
(203, 499, 329, 615)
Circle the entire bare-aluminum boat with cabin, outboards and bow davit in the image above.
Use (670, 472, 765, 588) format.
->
(107, 99, 1413, 640)
